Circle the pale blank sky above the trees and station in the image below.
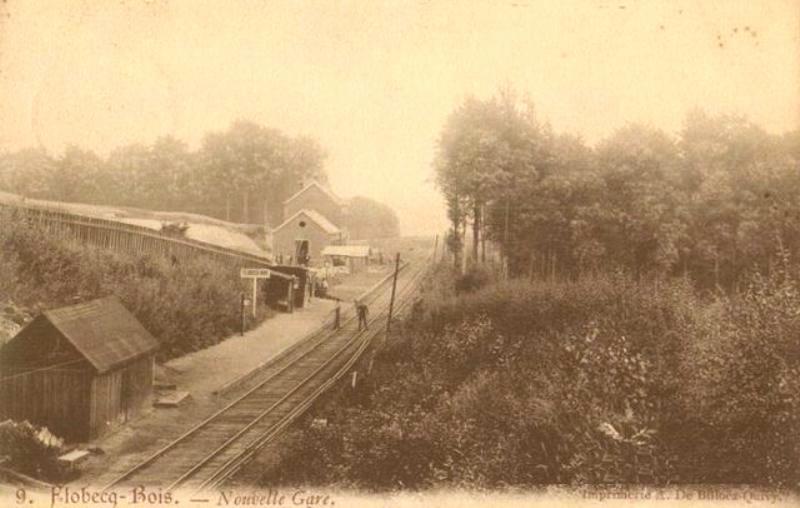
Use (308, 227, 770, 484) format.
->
(0, 0, 800, 233)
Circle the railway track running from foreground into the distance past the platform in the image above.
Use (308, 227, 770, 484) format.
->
(106, 256, 432, 492)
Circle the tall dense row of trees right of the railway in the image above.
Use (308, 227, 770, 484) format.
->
(435, 92, 800, 287)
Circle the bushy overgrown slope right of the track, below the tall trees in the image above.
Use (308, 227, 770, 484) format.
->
(249, 269, 800, 490)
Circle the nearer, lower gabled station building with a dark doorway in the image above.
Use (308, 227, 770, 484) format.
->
(272, 209, 343, 264)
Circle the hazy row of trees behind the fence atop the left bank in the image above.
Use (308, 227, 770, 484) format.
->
(0, 121, 327, 226)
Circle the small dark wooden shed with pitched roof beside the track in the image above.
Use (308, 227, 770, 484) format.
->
(0, 296, 159, 442)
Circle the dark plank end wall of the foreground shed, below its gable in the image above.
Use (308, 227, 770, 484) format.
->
(0, 366, 92, 441)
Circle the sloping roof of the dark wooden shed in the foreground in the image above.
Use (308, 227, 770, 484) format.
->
(39, 296, 159, 373)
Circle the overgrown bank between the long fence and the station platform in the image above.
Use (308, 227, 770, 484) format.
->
(0, 212, 269, 359)
